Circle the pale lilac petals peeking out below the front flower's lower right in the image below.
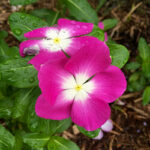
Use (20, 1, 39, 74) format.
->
(94, 119, 113, 140)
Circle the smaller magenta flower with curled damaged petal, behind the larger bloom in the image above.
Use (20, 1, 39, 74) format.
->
(20, 19, 93, 70)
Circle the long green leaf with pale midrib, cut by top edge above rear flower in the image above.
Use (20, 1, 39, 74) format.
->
(63, 0, 98, 24)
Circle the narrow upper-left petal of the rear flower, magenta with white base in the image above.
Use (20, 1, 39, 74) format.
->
(24, 27, 59, 38)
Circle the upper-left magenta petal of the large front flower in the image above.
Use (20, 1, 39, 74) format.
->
(38, 58, 70, 104)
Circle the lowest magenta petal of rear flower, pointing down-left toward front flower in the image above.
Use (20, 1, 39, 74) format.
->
(29, 51, 66, 70)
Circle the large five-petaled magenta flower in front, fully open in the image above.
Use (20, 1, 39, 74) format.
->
(35, 37, 126, 131)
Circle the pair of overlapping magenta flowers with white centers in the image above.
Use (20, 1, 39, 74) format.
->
(20, 19, 126, 131)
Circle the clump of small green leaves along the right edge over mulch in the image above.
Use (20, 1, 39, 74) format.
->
(126, 37, 150, 105)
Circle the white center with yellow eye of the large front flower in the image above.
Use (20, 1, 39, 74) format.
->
(62, 73, 95, 101)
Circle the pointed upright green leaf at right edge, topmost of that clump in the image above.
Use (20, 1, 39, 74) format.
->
(138, 37, 150, 60)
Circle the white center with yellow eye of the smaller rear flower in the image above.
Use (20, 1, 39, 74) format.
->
(42, 29, 72, 52)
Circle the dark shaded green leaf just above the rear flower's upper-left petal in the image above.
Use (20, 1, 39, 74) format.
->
(30, 8, 60, 26)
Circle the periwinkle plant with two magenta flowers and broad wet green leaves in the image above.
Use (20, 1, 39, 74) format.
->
(0, 0, 129, 150)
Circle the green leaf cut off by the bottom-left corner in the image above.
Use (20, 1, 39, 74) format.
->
(0, 125, 15, 150)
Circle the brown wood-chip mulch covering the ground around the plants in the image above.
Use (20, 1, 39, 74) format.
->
(0, 0, 150, 150)
